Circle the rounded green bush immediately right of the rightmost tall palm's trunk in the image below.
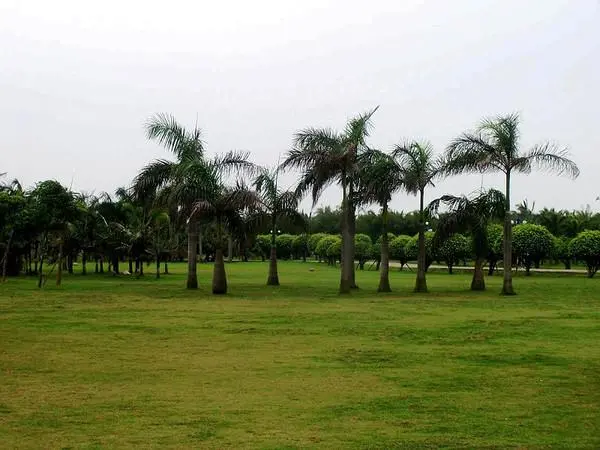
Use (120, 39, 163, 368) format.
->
(513, 223, 554, 275)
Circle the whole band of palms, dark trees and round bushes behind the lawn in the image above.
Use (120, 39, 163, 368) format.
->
(0, 109, 600, 295)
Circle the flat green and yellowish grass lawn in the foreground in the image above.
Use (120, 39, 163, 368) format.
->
(0, 263, 600, 449)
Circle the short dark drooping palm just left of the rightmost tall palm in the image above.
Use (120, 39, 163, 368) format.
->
(427, 189, 505, 291)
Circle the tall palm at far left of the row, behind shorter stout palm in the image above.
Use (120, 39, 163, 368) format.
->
(133, 114, 253, 289)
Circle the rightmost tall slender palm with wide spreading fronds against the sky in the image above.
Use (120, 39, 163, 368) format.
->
(445, 114, 579, 295)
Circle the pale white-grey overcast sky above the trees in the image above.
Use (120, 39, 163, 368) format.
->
(0, 0, 600, 210)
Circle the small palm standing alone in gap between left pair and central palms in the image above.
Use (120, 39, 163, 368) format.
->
(254, 168, 304, 286)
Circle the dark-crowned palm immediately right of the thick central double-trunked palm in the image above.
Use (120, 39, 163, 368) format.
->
(358, 150, 404, 292)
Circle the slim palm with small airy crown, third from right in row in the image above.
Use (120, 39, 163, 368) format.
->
(392, 141, 443, 292)
